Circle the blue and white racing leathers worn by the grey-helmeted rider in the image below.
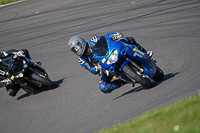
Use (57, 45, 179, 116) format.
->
(79, 32, 151, 93)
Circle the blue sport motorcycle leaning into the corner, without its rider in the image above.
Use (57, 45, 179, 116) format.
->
(92, 35, 164, 88)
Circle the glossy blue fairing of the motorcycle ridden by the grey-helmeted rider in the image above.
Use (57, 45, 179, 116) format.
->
(93, 34, 156, 81)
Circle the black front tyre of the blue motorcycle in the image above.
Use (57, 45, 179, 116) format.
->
(122, 64, 156, 88)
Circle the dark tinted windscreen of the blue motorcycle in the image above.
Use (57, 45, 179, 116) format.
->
(93, 36, 108, 56)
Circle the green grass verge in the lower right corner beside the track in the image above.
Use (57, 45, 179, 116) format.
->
(97, 94, 200, 133)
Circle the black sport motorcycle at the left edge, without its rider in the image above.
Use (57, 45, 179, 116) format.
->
(1, 54, 57, 92)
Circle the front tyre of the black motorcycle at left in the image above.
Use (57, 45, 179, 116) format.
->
(31, 73, 57, 88)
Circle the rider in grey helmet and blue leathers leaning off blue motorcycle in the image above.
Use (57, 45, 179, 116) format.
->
(68, 32, 153, 93)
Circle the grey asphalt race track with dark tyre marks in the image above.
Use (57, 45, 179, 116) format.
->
(0, 0, 200, 133)
